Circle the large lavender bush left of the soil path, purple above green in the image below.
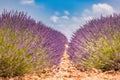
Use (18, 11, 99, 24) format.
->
(0, 11, 67, 77)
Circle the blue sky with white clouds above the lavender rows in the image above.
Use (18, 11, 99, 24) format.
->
(0, 0, 120, 40)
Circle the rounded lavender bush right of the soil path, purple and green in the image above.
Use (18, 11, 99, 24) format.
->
(68, 14, 120, 71)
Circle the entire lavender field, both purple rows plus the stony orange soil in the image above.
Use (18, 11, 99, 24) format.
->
(0, 10, 120, 80)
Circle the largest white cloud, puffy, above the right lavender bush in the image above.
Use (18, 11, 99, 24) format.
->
(81, 3, 117, 21)
